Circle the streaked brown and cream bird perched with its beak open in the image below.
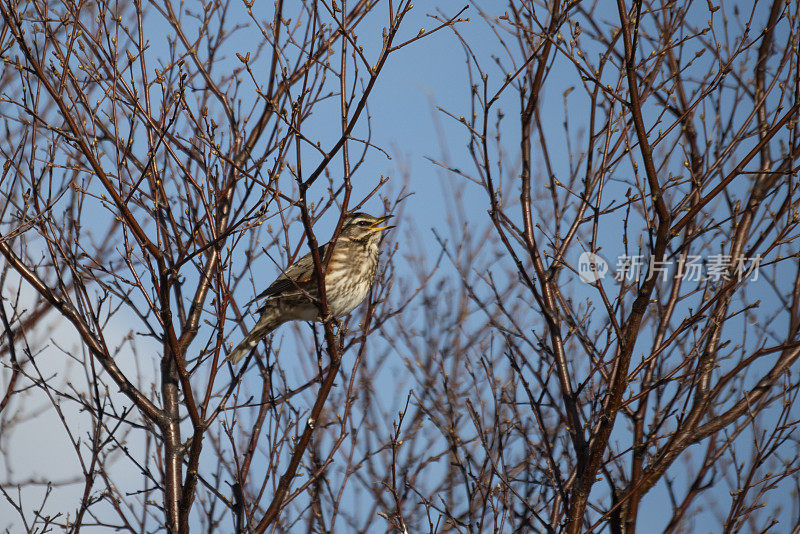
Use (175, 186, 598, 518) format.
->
(227, 212, 393, 364)
